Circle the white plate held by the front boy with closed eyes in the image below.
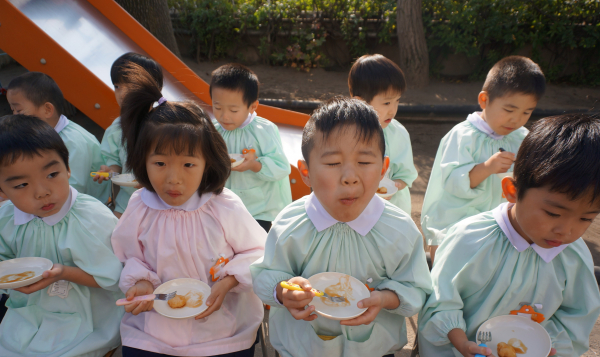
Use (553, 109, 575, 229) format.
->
(308, 272, 371, 320)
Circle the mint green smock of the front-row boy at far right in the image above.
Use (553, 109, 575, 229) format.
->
(419, 211, 600, 357)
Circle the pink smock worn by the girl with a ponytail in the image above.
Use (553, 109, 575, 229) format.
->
(112, 189, 267, 356)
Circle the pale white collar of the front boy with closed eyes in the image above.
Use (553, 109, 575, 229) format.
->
(304, 192, 385, 237)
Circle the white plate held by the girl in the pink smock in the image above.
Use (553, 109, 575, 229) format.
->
(154, 278, 210, 319)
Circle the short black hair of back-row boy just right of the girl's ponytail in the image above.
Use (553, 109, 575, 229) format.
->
(209, 63, 260, 107)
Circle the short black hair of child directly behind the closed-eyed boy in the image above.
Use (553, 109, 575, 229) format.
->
(348, 54, 406, 103)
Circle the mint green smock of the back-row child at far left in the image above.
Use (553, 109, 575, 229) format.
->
(58, 120, 110, 203)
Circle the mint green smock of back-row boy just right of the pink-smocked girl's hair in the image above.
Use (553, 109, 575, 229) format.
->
(213, 116, 292, 222)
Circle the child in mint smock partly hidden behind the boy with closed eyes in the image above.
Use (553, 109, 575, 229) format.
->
(348, 55, 418, 216)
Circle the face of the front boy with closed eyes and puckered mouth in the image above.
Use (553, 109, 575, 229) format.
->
(307, 126, 384, 222)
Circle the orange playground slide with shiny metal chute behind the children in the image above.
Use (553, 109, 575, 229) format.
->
(0, 0, 310, 199)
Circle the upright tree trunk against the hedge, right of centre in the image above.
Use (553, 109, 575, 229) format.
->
(396, 0, 429, 88)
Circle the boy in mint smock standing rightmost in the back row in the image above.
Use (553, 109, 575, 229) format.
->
(421, 56, 546, 261)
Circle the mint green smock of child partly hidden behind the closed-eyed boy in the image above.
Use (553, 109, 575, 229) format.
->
(383, 119, 418, 216)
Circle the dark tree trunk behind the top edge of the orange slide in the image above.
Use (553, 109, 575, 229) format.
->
(116, 0, 181, 57)
